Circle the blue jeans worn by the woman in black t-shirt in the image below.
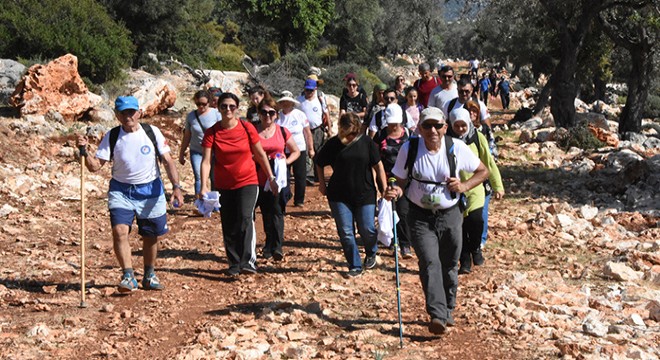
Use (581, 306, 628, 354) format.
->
(329, 201, 378, 270)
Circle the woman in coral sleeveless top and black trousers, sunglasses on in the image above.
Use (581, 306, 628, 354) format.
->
(257, 97, 300, 261)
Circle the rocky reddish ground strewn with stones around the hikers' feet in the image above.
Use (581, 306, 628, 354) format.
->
(0, 96, 660, 359)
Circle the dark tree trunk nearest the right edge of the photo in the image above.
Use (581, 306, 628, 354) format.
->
(619, 44, 653, 134)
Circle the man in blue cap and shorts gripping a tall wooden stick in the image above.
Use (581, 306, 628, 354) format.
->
(77, 96, 183, 294)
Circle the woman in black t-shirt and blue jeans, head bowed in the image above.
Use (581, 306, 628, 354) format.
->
(314, 112, 386, 277)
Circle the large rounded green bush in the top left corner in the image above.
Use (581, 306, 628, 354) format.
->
(0, 0, 134, 82)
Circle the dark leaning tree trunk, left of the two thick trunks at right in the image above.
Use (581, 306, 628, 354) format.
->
(550, 36, 579, 128)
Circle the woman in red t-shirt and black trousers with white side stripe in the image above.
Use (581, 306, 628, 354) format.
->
(200, 93, 278, 275)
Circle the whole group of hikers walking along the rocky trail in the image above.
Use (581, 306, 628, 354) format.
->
(77, 63, 506, 334)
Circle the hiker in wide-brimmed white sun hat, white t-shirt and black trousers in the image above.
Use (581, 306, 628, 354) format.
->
(277, 91, 314, 207)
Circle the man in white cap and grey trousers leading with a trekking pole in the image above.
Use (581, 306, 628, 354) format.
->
(385, 107, 488, 334)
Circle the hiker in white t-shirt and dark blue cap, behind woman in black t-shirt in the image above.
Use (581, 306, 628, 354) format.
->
(297, 75, 330, 184)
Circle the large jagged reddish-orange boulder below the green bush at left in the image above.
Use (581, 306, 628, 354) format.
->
(11, 54, 102, 122)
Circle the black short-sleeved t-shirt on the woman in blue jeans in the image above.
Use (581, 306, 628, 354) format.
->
(314, 135, 380, 206)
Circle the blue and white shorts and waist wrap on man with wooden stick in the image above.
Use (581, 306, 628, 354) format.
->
(108, 178, 169, 237)
